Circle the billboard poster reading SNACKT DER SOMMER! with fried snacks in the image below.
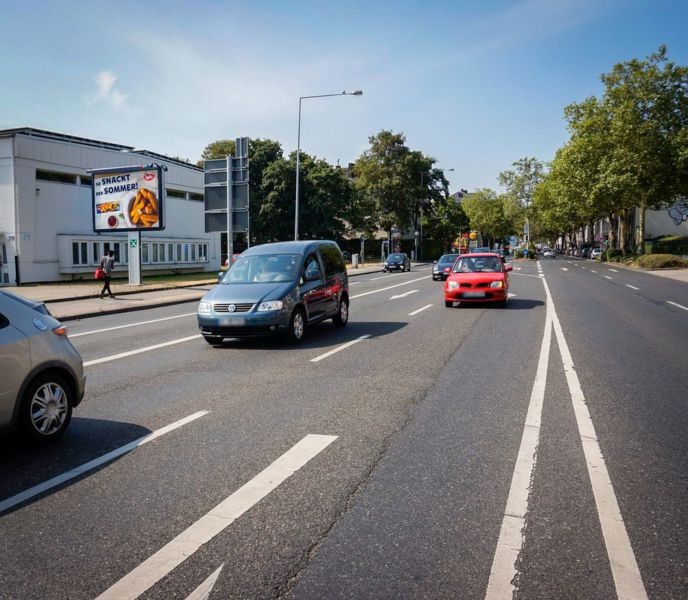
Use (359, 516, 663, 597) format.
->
(91, 165, 164, 232)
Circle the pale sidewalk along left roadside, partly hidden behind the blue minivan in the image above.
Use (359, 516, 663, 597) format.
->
(2, 263, 382, 321)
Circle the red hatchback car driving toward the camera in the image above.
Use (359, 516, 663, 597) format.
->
(444, 252, 513, 307)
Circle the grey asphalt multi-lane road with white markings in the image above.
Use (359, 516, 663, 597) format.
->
(0, 258, 688, 599)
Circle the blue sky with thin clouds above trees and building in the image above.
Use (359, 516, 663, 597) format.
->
(0, 0, 688, 191)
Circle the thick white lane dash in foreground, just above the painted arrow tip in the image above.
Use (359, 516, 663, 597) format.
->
(96, 434, 337, 600)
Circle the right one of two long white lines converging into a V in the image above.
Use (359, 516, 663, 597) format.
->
(543, 281, 647, 600)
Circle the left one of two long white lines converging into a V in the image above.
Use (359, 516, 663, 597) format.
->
(485, 298, 552, 600)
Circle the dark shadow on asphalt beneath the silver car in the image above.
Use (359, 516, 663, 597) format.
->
(0, 417, 151, 516)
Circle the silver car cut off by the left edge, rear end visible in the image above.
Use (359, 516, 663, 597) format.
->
(0, 290, 86, 444)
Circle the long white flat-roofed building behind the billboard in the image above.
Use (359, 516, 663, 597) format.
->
(0, 128, 220, 285)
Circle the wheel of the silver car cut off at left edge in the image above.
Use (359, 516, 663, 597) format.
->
(19, 373, 74, 444)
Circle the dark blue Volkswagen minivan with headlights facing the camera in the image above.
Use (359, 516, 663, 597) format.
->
(198, 240, 349, 345)
